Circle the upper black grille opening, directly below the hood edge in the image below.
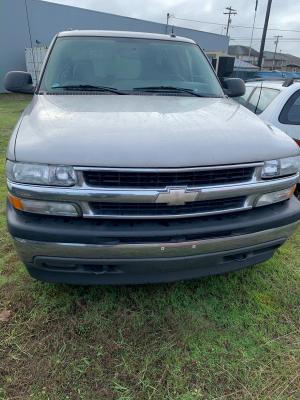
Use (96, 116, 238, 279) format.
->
(83, 167, 254, 189)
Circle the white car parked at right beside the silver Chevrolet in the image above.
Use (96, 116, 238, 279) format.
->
(236, 79, 300, 146)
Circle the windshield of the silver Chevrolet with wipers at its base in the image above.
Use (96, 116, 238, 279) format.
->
(40, 37, 223, 97)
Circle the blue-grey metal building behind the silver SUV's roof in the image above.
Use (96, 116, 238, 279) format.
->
(0, 0, 228, 92)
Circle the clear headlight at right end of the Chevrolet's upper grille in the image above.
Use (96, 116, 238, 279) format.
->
(261, 156, 300, 179)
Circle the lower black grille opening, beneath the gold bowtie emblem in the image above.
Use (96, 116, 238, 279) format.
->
(90, 197, 246, 217)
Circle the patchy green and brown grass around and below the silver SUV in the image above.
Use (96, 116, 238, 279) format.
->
(0, 95, 300, 400)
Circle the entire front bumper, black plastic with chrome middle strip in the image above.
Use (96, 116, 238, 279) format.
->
(8, 198, 300, 284)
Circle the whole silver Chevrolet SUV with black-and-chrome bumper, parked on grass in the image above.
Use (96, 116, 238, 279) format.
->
(5, 31, 300, 284)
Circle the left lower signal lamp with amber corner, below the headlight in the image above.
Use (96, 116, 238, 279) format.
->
(8, 193, 79, 217)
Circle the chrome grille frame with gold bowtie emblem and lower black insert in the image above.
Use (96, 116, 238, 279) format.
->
(8, 163, 299, 219)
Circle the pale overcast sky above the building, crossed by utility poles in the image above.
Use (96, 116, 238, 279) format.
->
(45, 0, 300, 57)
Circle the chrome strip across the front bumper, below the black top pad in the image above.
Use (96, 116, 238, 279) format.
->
(14, 221, 299, 262)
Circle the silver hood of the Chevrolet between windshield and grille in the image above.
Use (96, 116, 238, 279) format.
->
(11, 94, 299, 168)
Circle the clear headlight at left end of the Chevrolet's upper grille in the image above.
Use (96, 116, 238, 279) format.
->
(6, 161, 76, 186)
